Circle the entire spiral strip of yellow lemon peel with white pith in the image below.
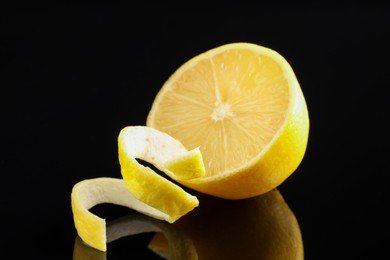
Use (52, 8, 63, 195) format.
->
(71, 126, 205, 251)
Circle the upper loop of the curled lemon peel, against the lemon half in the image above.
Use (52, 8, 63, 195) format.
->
(118, 126, 204, 223)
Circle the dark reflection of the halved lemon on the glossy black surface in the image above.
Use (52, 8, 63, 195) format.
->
(174, 190, 304, 260)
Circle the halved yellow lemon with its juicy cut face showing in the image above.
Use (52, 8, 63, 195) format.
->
(146, 42, 309, 199)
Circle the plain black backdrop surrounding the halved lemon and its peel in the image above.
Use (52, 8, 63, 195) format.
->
(0, 2, 390, 260)
